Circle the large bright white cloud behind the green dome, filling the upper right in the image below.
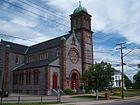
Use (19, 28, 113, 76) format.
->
(43, 0, 140, 44)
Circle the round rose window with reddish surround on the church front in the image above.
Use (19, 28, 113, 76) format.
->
(69, 48, 79, 63)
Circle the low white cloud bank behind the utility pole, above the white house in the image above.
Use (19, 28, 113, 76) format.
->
(94, 46, 140, 80)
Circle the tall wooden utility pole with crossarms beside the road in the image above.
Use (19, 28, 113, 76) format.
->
(117, 42, 126, 100)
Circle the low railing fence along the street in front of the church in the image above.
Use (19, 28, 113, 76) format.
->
(1, 94, 61, 105)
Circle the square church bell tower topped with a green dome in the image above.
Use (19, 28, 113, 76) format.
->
(70, 2, 93, 72)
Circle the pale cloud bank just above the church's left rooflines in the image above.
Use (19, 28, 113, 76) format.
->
(0, 20, 51, 45)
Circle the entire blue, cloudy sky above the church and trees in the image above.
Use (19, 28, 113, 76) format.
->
(0, 0, 140, 80)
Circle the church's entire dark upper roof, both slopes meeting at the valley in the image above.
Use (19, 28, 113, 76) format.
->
(1, 34, 70, 54)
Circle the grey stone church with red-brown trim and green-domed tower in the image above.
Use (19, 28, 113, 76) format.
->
(0, 4, 93, 94)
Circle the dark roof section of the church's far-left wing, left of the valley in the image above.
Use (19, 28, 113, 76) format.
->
(1, 40, 28, 54)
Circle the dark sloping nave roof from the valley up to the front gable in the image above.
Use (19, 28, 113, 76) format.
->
(27, 34, 70, 54)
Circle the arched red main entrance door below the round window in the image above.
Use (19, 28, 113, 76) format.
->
(71, 72, 79, 90)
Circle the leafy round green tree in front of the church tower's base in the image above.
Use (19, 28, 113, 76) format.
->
(83, 61, 115, 89)
